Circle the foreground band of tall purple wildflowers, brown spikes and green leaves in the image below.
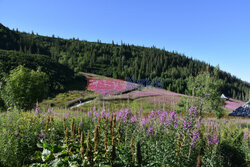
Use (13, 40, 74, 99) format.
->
(0, 107, 250, 167)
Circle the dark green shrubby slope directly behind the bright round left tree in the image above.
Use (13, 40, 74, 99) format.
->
(0, 50, 74, 92)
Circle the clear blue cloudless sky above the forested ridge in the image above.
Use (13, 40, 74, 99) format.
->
(0, 0, 250, 82)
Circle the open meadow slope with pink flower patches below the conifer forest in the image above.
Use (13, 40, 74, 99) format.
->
(40, 73, 244, 117)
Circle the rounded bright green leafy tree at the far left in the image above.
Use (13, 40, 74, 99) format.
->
(0, 66, 49, 109)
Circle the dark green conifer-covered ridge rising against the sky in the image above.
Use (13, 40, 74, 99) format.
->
(0, 24, 250, 100)
